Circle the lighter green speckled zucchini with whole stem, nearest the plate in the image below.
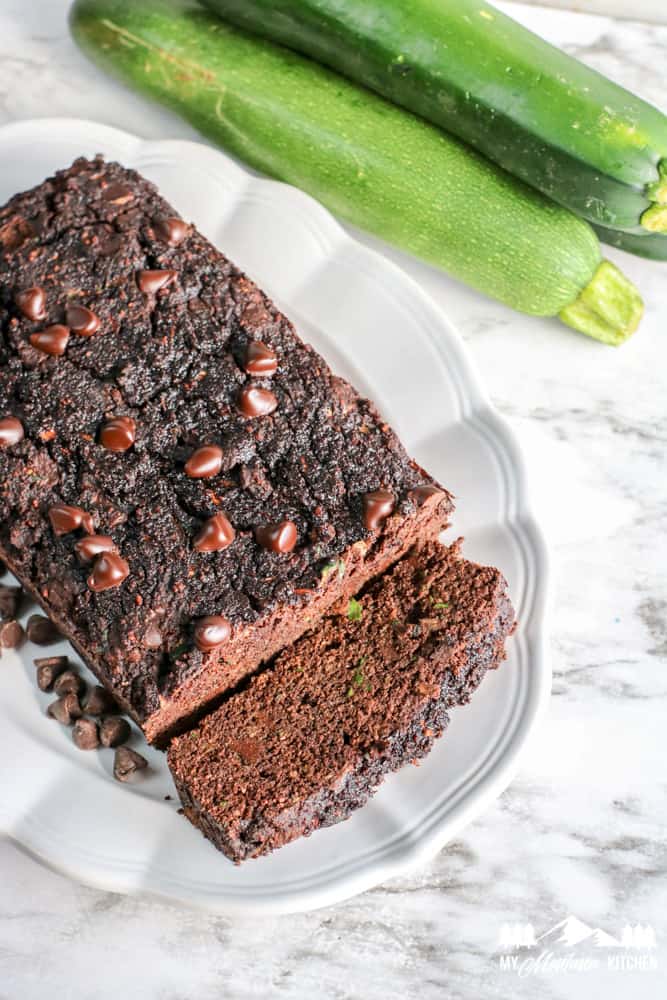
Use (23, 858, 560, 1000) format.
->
(70, 0, 642, 344)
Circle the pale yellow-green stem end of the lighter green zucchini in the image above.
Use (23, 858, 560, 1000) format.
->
(558, 260, 644, 347)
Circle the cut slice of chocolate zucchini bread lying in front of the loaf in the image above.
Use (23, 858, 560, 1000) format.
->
(168, 542, 514, 861)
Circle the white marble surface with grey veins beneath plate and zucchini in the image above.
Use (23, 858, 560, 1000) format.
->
(0, 0, 667, 1000)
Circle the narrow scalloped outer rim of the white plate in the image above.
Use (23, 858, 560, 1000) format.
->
(0, 117, 551, 915)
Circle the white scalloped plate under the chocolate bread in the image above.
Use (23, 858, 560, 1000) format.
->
(0, 119, 551, 913)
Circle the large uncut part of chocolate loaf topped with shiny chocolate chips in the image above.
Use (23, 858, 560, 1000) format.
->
(0, 158, 452, 742)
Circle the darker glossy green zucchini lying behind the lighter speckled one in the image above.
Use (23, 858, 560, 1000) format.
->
(204, 0, 667, 232)
